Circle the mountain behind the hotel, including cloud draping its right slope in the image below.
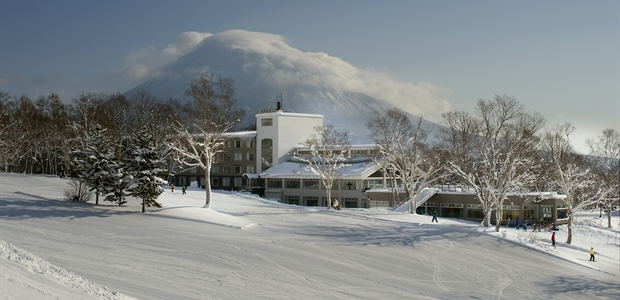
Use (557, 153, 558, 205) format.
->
(125, 30, 447, 143)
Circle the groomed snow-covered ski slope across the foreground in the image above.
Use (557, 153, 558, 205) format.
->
(0, 173, 620, 299)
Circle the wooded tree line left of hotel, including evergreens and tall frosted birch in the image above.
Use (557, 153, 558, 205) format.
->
(0, 73, 244, 212)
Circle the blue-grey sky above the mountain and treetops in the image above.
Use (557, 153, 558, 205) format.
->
(0, 0, 620, 148)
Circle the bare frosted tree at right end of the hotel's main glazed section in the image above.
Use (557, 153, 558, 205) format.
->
(366, 108, 440, 213)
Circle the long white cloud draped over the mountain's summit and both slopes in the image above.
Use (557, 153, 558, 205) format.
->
(114, 30, 450, 121)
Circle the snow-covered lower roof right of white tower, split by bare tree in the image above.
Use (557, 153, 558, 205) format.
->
(260, 161, 381, 179)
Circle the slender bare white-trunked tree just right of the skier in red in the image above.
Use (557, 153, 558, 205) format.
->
(543, 123, 601, 244)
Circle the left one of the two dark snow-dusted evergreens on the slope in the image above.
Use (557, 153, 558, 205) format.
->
(73, 124, 123, 205)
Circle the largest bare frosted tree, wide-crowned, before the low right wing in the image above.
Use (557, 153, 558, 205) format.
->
(442, 95, 545, 231)
